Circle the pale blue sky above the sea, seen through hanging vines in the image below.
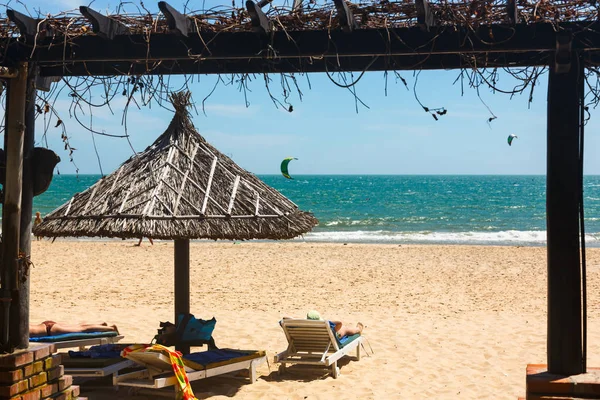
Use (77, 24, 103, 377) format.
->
(12, 0, 600, 174)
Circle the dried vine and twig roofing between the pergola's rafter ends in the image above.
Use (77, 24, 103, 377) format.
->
(0, 0, 598, 40)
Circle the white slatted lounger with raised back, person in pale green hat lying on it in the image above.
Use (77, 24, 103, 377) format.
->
(275, 319, 362, 378)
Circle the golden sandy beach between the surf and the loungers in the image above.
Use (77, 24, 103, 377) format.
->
(30, 240, 600, 399)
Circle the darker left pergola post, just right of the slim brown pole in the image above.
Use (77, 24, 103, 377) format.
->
(10, 63, 37, 349)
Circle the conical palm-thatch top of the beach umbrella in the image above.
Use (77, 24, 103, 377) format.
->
(34, 92, 318, 240)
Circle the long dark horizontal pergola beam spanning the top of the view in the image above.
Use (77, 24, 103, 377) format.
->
(9, 22, 600, 76)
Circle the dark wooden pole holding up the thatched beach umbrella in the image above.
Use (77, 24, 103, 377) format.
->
(175, 239, 190, 354)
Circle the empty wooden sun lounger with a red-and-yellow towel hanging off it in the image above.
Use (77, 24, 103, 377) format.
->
(113, 349, 267, 389)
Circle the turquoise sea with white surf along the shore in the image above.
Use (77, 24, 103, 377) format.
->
(34, 175, 600, 247)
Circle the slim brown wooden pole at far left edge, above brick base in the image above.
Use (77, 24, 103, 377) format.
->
(1, 63, 27, 351)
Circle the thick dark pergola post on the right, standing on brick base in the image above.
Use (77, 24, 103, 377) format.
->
(546, 53, 585, 375)
